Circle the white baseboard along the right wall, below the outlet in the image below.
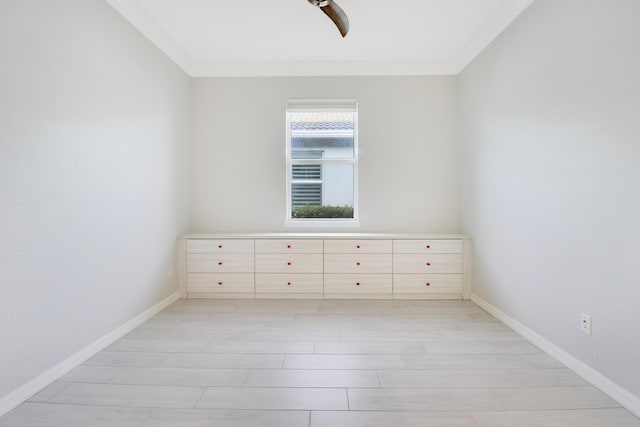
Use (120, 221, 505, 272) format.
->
(471, 293, 640, 417)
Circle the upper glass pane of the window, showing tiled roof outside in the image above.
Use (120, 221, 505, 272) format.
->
(291, 112, 354, 159)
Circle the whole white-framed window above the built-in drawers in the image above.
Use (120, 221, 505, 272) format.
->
(286, 100, 358, 225)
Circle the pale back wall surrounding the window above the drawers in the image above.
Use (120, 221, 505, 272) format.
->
(192, 76, 458, 232)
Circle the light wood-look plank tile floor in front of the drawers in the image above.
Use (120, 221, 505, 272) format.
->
(0, 300, 640, 427)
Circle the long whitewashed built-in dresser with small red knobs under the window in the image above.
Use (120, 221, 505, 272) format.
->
(178, 233, 471, 299)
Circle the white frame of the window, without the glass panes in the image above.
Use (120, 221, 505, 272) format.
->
(285, 99, 360, 227)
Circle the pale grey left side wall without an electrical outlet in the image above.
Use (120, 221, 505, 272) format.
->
(0, 0, 190, 401)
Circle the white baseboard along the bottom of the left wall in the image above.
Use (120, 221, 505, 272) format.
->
(0, 292, 179, 416)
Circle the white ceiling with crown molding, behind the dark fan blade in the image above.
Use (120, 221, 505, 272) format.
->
(106, 0, 534, 77)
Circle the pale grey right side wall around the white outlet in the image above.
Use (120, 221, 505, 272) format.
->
(458, 0, 640, 402)
